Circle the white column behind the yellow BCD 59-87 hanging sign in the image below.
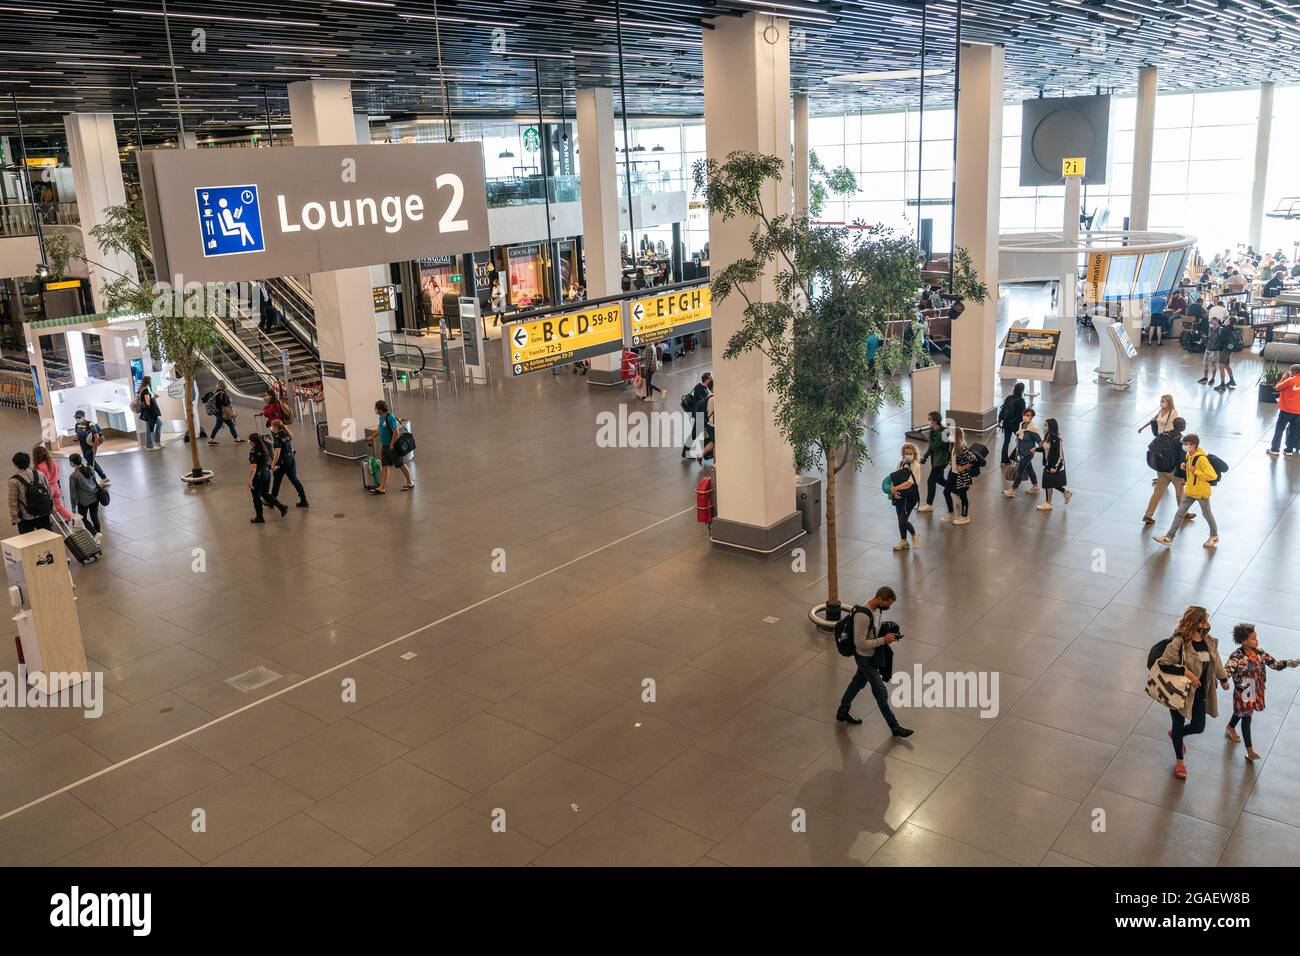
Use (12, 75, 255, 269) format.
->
(576, 88, 625, 385)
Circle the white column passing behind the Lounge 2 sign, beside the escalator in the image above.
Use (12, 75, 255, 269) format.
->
(289, 79, 384, 455)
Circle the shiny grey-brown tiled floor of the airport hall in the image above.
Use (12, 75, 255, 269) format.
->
(0, 295, 1300, 865)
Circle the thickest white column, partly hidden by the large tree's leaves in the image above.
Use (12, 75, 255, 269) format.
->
(703, 13, 800, 551)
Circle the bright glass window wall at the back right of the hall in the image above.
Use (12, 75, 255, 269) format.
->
(809, 87, 1284, 264)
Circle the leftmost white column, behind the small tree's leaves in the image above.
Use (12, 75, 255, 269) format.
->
(64, 113, 138, 312)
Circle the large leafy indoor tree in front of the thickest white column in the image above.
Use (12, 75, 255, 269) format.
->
(693, 152, 946, 627)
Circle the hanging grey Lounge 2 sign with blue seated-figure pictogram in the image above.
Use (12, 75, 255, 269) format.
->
(142, 143, 489, 282)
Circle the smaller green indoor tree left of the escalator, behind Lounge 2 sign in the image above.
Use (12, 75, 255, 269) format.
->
(46, 203, 219, 484)
